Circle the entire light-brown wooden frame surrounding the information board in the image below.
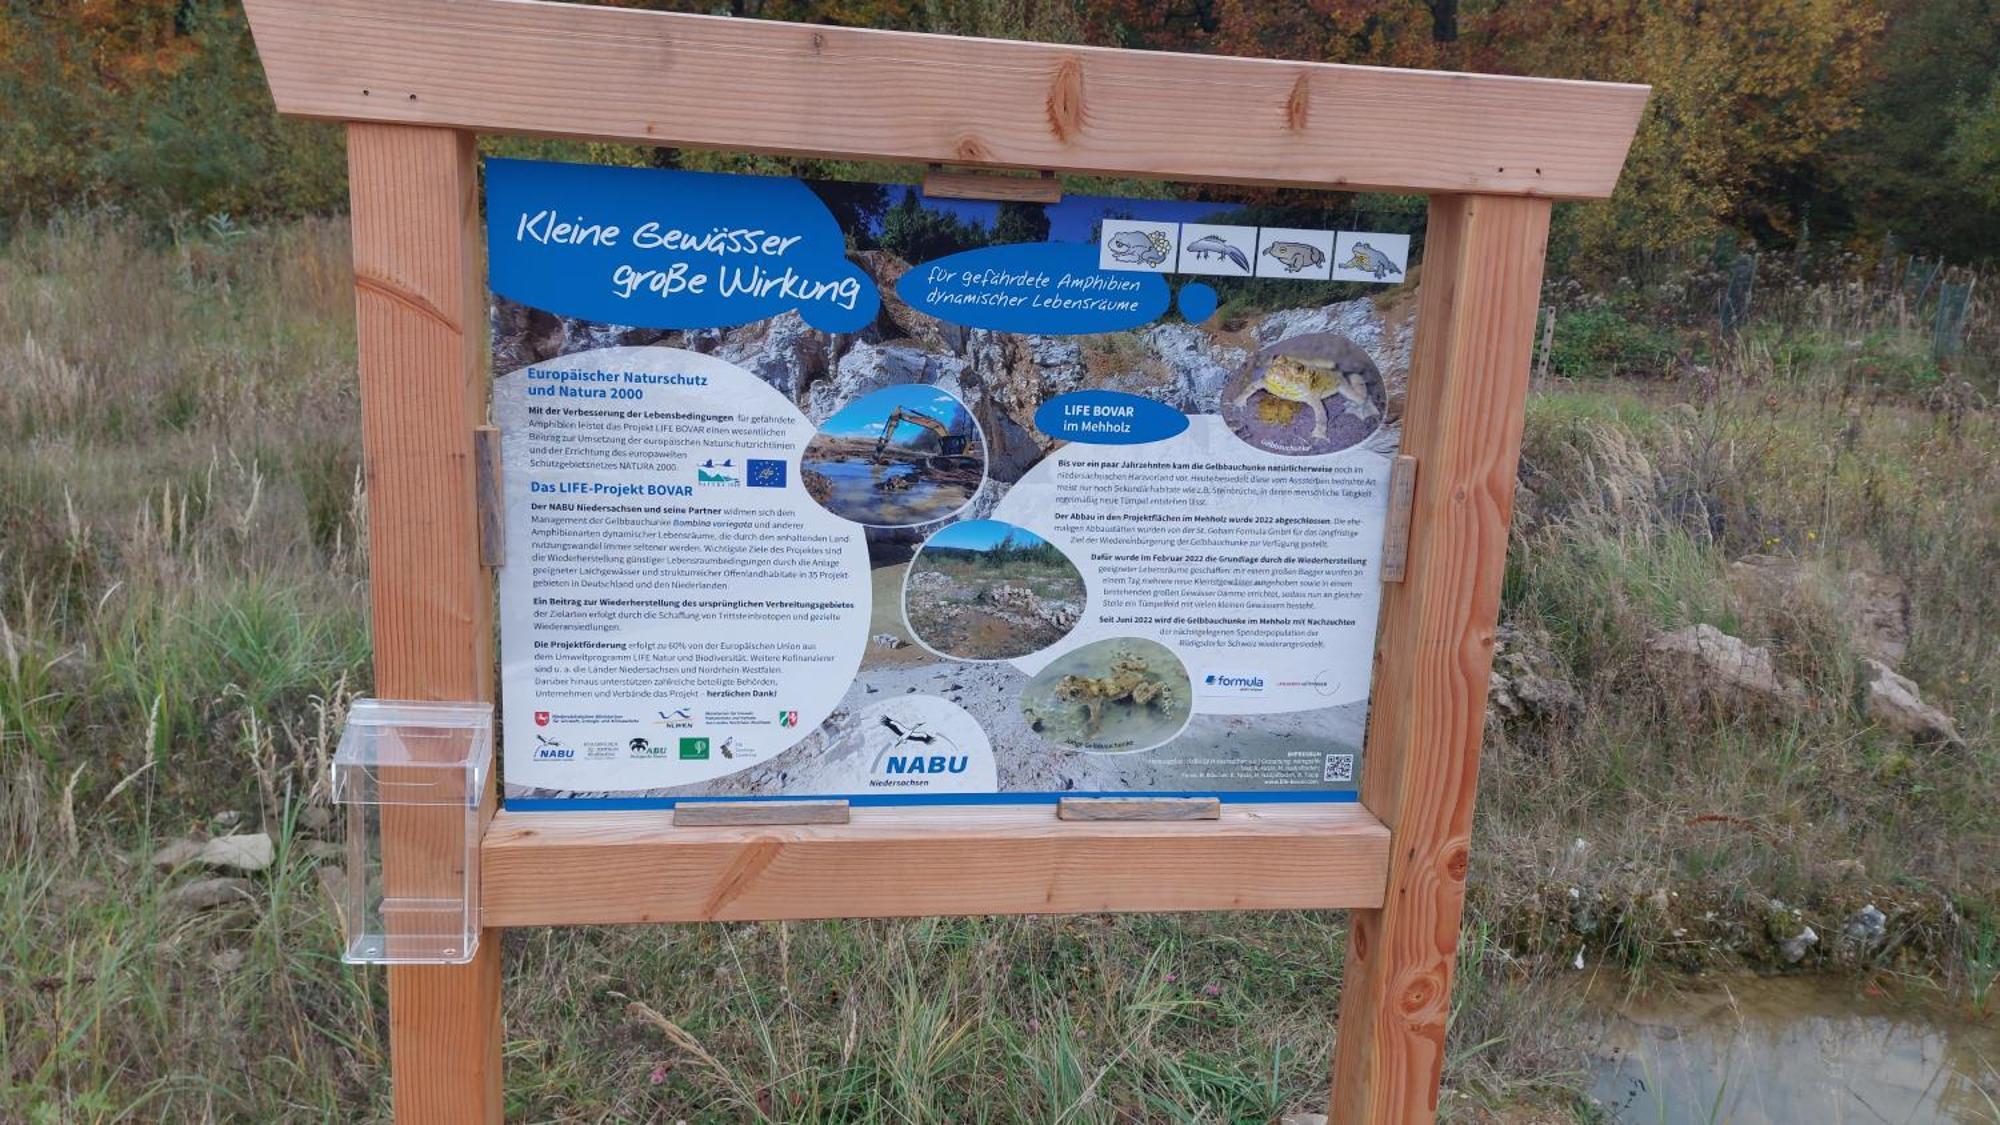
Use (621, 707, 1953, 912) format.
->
(246, 0, 1646, 1123)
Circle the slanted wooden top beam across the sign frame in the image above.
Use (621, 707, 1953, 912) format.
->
(246, 0, 1646, 198)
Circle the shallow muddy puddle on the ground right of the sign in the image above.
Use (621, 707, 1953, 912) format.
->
(1590, 977, 2000, 1125)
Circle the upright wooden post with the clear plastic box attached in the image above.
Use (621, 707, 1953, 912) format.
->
(348, 124, 500, 1121)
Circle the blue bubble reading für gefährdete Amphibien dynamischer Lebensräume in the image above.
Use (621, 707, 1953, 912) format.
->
(896, 242, 1172, 336)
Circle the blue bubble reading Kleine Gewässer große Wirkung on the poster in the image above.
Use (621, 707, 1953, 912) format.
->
(486, 158, 882, 332)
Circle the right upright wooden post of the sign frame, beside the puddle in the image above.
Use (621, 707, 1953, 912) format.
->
(1330, 196, 1550, 1123)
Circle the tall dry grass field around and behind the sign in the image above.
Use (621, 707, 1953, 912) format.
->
(0, 216, 2000, 1121)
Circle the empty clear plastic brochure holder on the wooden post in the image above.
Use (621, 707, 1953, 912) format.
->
(334, 699, 494, 965)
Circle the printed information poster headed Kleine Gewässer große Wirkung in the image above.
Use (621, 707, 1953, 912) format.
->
(486, 160, 1420, 811)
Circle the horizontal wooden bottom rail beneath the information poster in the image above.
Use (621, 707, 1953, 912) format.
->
(482, 805, 1388, 927)
